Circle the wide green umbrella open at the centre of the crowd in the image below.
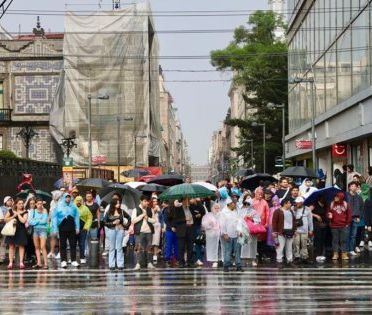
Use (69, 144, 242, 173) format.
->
(159, 184, 214, 200)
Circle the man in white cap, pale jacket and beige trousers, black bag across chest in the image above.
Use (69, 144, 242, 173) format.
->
(293, 197, 314, 262)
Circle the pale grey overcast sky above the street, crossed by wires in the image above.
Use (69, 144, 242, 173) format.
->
(1, 0, 268, 164)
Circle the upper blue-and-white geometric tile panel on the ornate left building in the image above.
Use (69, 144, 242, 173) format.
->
(14, 75, 59, 114)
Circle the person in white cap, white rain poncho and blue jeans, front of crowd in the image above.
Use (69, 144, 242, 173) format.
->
(220, 198, 243, 272)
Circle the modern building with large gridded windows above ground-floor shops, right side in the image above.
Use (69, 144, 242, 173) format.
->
(286, 0, 372, 183)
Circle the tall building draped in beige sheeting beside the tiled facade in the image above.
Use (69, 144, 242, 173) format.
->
(50, 4, 161, 166)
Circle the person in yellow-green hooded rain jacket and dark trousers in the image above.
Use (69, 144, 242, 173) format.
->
(74, 196, 93, 264)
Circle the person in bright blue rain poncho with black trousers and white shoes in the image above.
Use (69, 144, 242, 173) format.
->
(52, 193, 80, 268)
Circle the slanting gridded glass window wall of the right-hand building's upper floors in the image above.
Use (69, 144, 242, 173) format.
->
(288, 0, 372, 132)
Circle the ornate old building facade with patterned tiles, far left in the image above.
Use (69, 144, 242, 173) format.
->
(0, 23, 63, 162)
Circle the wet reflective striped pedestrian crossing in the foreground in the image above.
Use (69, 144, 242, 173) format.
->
(0, 267, 372, 314)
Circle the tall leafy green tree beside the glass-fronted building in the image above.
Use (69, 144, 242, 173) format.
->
(211, 11, 288, 172)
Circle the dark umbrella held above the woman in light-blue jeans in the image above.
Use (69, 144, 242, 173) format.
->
(99, 183, 141, 209)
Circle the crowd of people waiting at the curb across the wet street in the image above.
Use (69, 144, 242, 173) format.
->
(0, 165, 372, 272)
